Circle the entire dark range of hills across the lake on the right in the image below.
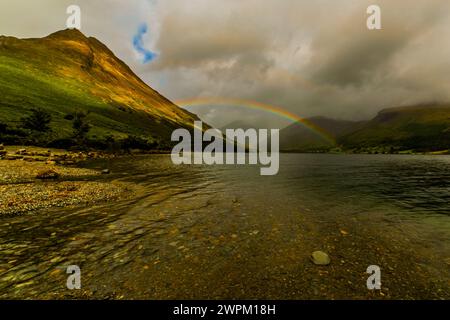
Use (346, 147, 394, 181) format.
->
(280, 104, 450, 153)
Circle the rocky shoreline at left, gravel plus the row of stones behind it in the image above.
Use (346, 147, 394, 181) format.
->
(0, 146, 132, 216)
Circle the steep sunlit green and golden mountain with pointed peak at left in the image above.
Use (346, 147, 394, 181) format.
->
(0, 29, 198, 146)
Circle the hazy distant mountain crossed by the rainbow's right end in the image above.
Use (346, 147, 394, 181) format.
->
(280, 117, 364, 152)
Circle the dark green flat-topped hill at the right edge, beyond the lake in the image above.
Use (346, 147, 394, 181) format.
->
(338, 104, 450, 151)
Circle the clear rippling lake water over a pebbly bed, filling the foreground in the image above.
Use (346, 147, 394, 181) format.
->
(0, 154, 450, 299)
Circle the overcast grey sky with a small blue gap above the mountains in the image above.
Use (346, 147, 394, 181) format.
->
(0, 0, 450, 126)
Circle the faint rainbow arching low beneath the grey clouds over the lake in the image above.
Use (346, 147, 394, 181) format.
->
(175, 98, 336, 145)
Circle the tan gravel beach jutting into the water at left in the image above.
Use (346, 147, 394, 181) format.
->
(0, 146, 131, 215)
